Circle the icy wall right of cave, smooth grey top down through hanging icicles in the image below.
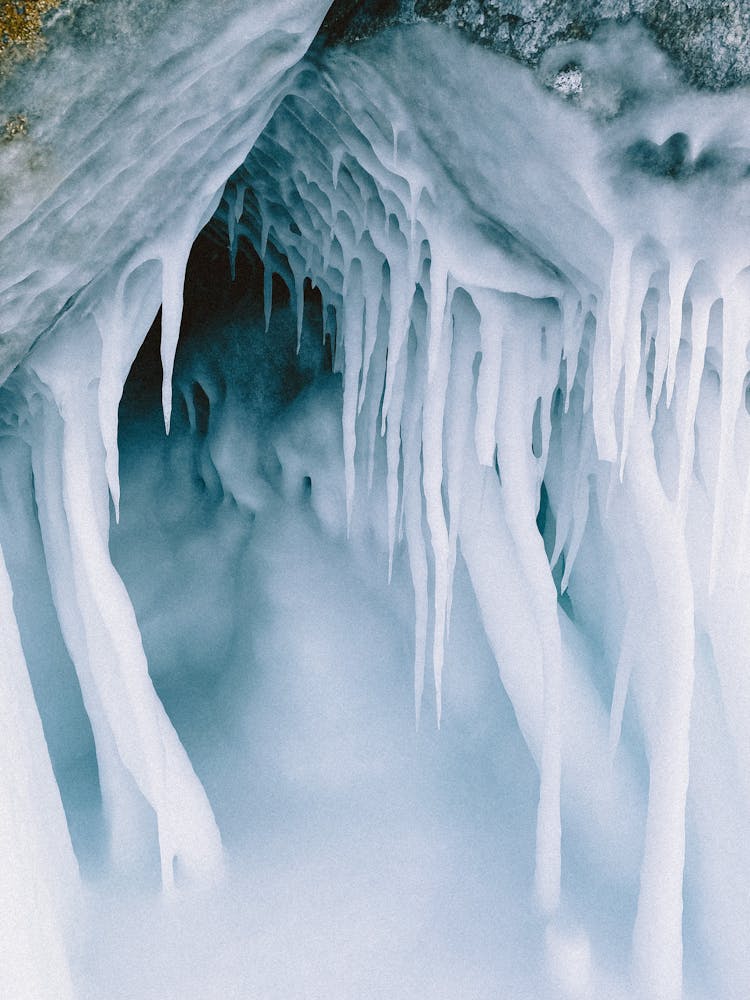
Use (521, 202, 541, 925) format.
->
(204, 28, 748, 997)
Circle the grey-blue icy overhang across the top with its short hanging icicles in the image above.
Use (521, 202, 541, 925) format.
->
(0, 15, 750, 564)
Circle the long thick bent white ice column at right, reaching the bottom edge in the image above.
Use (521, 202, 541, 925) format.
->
(625, 376, 695, 1000)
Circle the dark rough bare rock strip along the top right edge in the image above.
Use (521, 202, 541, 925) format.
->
(321, 0, 750, 89)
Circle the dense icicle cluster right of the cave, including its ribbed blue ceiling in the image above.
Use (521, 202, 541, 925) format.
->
(217, 58, 750, 998)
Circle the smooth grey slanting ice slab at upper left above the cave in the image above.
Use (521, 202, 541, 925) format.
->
(0, 0, 327, 378)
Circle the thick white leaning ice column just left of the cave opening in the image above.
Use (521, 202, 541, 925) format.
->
(29, 313, 226, 886)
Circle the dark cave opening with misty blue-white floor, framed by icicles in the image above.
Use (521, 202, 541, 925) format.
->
(88, 186, 548, 995)
